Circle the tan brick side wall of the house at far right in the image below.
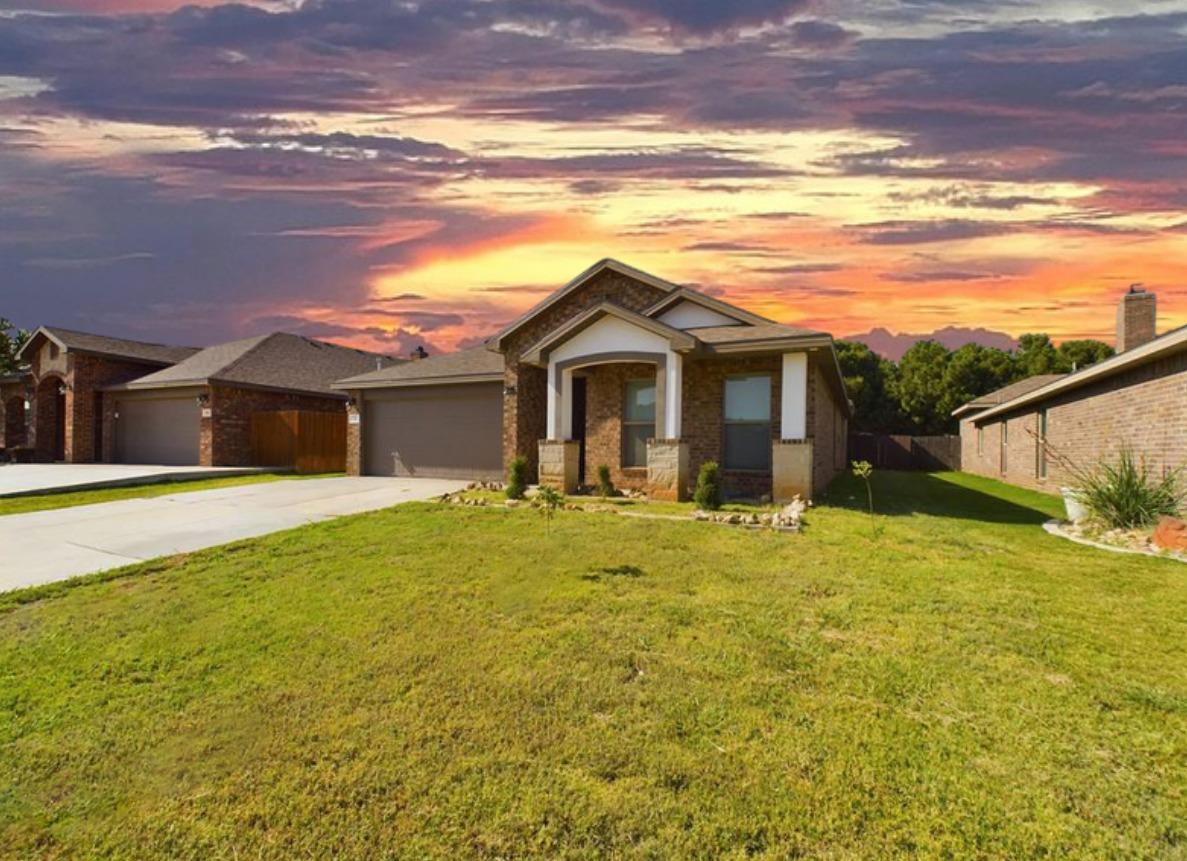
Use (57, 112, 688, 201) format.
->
(960, 352, 1187, 484)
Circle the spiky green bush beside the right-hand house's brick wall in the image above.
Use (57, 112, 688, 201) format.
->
(1074, 448, 1183, 528)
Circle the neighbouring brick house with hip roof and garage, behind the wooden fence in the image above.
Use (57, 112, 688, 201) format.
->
(102, 333, 395, 467)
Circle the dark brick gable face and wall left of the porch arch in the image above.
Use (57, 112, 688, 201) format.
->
(503, 270, 667, 476)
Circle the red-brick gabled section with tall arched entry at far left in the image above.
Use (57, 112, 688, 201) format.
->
(15, 327, 197, 463)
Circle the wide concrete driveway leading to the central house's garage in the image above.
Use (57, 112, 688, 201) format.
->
(0, 477, 466, 591)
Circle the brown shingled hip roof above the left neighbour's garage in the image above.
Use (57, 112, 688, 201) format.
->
(112, 331, 395, 395)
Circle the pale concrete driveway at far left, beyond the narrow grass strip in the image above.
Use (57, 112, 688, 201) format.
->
(0, 463, 266, 496)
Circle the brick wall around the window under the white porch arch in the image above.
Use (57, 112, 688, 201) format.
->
(584, 362, 662, 490)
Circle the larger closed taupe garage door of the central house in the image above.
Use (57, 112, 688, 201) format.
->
(362, 382, 503, 479)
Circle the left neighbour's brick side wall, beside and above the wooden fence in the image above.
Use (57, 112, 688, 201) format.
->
(207, 386, 345, 467)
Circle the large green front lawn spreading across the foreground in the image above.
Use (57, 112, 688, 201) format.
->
(0, 474, 1187, 861)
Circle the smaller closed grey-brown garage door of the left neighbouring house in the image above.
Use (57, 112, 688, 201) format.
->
(115, 394, 199, 466)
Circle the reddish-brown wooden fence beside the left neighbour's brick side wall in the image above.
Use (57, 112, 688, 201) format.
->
(252, 410, 347, 473)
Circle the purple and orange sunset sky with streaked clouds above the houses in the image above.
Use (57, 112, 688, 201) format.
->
(0, 0, 1187, 353)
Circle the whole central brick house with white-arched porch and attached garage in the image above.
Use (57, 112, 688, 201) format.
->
(337, 260, 850, 499)
